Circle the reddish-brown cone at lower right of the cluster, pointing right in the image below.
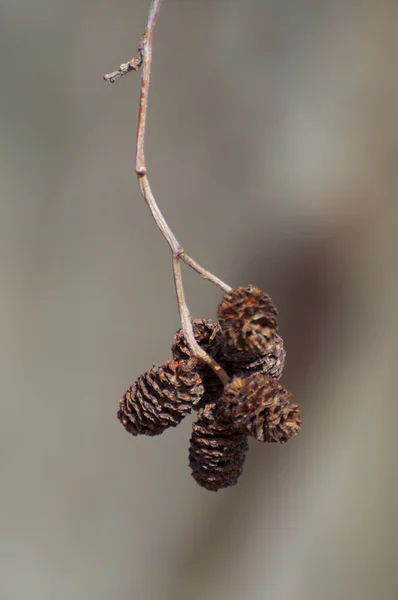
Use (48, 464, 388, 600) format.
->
(220, 373, 301, 444)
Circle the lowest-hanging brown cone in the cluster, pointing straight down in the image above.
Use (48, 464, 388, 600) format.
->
(189, 403, 248, 492)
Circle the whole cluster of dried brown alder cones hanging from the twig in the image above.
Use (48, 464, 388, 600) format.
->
(117, 285, 301, 491)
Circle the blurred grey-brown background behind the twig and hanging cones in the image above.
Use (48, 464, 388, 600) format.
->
(0, 0, 398, 600)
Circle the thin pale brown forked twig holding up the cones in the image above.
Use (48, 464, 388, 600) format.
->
(104, 0, 232, 384)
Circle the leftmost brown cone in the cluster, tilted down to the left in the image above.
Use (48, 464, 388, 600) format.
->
(117, 359, 204, 436)
